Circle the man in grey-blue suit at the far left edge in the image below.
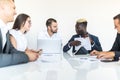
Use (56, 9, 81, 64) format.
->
(0, 0, 39, 67)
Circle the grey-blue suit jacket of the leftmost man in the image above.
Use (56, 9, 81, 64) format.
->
(0, 33, 29, 67)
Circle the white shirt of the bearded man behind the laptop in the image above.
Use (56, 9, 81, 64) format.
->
(38, 30, 62, 40)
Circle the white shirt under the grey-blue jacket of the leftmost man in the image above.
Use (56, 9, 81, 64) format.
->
(0, 19, 8, 48)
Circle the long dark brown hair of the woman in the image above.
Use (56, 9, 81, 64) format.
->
(13, 13, 30, 30)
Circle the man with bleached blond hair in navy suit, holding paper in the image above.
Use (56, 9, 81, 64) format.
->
(63, 18, 102, 52)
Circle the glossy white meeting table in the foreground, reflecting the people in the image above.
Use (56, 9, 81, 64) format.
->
(0, 53, 120, 80)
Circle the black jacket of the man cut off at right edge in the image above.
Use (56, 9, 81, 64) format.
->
(110, 33, 120, 61)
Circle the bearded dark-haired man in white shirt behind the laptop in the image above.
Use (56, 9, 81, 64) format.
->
(38, 18, 61, 39)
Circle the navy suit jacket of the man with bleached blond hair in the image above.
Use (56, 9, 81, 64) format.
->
(63, 34, 102, 52)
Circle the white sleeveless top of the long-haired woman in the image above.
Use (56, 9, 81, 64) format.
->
(10, 29, 27, 51)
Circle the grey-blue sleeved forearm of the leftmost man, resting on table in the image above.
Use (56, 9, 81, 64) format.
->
(0, 51, 29, 67)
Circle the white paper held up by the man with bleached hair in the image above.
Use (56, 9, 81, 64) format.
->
(75, 37, 91, 50)
